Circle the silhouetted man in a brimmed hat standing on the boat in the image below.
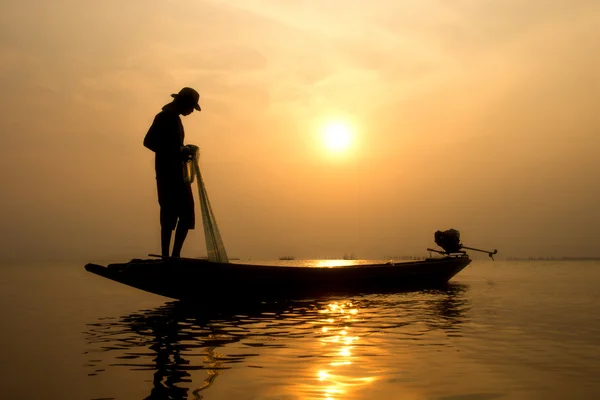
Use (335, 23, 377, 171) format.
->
(144, 87, 201, 257)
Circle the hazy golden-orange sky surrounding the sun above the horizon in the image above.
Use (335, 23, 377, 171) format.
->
(0, 0, 600, 261)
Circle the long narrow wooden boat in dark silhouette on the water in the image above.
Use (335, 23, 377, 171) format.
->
(85, 254, 471, 302)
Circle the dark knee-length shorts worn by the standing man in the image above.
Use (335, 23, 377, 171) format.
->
(156, 179, 196, 230)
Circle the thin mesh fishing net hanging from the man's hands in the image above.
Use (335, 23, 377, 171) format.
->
(184, 145, 229, 263)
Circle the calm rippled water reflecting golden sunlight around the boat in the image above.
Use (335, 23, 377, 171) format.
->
(0, 261, 600, 400)
